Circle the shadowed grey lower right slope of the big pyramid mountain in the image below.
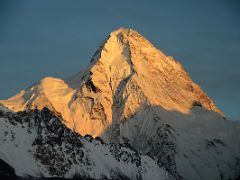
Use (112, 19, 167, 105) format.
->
(120, 105, 240, 180)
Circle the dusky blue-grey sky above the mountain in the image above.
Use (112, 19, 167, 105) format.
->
(0, 0, 240, 120)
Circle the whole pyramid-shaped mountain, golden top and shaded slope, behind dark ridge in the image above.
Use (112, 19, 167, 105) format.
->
(0, 28, 240, 179)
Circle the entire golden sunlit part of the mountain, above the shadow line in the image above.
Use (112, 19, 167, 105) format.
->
(0, 28, 223, 136)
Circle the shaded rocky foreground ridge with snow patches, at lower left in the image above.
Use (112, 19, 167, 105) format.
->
(0, 108, 168, 180)
